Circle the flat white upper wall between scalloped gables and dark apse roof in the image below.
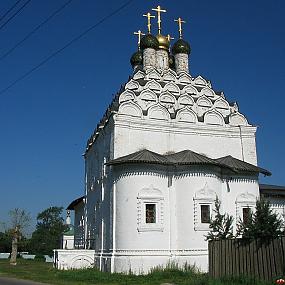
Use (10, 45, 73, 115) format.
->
(114, 115, 257, 165)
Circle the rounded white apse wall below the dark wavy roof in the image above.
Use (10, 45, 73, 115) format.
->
(109, 162, 259, 273)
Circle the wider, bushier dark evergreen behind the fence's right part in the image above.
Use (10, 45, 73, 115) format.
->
(237, 199, 283, 240)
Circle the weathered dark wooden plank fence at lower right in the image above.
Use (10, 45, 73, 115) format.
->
(206, 237, 285, 281)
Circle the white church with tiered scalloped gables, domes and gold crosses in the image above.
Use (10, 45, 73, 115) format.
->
(54, 6, 285, 274)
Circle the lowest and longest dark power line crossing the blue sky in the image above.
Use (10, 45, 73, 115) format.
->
(0, 0, 134, 95)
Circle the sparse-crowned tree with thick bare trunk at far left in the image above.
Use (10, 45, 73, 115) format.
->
(9, 208, 31, 265)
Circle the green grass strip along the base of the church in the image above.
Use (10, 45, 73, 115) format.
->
(0, 259, 273, 285)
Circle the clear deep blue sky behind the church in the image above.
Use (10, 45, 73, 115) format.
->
(0, 0, 285, 227)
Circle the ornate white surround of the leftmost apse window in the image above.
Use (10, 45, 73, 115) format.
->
(137, 185, 164, 232)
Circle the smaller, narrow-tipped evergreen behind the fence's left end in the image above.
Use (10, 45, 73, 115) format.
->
(206, 197, 234, 240)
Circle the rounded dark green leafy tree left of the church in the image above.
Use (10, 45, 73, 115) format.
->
(30, 207, 67, 255)
